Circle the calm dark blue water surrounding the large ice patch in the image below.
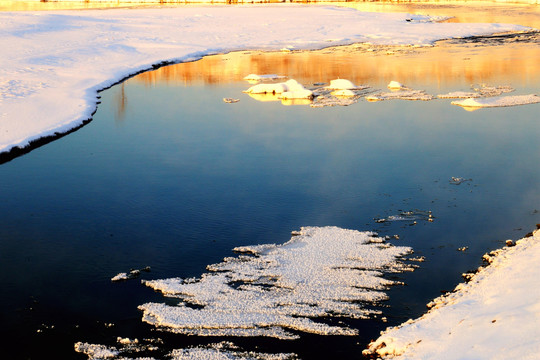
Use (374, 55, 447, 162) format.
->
(0, 61, 540, 358)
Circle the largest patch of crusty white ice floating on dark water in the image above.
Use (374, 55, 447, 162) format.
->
(139, 227, 413, 339)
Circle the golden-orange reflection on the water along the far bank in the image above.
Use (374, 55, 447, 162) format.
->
(131, 42, 540, 92)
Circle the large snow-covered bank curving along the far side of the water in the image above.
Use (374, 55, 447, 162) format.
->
(0, 4, 526, 152)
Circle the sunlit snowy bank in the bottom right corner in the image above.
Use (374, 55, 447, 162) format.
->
(362, 226, 540, 359)
